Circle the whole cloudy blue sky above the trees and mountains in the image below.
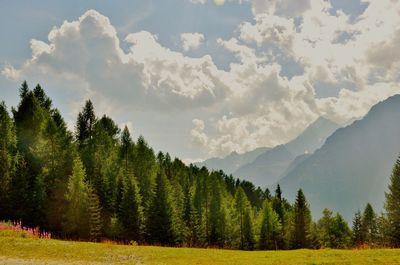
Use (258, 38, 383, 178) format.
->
(0, 0, 400, 162)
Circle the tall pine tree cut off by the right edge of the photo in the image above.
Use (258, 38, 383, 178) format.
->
(385, 157, 400, 247)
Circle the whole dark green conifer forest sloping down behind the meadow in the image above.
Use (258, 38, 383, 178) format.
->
(0, 82, 400, 250)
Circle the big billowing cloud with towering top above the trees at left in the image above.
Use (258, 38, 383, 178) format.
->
(3, 10, 228, 109)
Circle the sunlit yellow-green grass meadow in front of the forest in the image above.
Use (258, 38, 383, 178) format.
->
(0, 232, 400, 265)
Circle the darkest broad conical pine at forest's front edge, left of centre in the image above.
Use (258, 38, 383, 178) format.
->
(147, 171, 176, 245)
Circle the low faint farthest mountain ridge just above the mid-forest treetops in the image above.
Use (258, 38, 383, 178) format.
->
(195, 147, 270, 174)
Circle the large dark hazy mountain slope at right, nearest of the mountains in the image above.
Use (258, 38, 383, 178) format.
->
(271, 95, 400, 220)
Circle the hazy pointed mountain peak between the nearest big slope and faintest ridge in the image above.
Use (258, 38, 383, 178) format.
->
(233, 117, 339, 187)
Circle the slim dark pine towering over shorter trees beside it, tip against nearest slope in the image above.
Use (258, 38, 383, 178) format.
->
(292, 189, 311, 249)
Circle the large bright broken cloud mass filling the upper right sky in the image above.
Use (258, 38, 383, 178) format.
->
(195, 0, 400, 155)
